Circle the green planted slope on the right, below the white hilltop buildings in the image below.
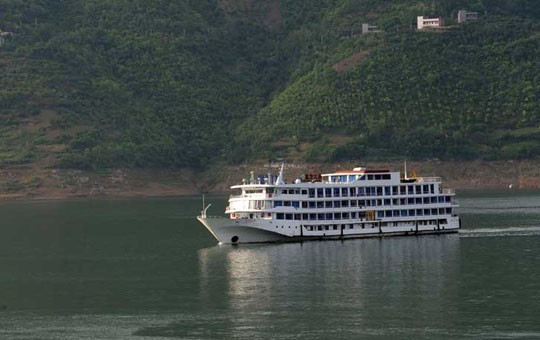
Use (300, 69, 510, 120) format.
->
(235, 12, 540, 160)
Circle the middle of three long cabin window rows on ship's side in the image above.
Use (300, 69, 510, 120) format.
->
(274, 196, 451, 209)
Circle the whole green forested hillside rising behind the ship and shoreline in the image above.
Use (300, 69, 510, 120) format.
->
(0, 0, 540, 169)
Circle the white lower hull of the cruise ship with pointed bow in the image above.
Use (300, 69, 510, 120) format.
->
(197, 216, 460, 244)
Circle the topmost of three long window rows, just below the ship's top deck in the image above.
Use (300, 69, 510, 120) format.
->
(281, 184, 435, 198)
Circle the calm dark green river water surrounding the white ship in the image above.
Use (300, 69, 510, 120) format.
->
(0, 191, 540, 340)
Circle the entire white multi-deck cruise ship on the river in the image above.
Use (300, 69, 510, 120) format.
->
(197, 166, 460, 244)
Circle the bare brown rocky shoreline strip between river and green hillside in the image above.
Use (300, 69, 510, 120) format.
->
(0, 160, 540, 199)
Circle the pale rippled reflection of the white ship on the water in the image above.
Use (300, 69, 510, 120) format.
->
(199, 235, 459, 338)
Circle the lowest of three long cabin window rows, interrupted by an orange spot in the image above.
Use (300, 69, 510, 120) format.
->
(276, 208, 452, 221)
